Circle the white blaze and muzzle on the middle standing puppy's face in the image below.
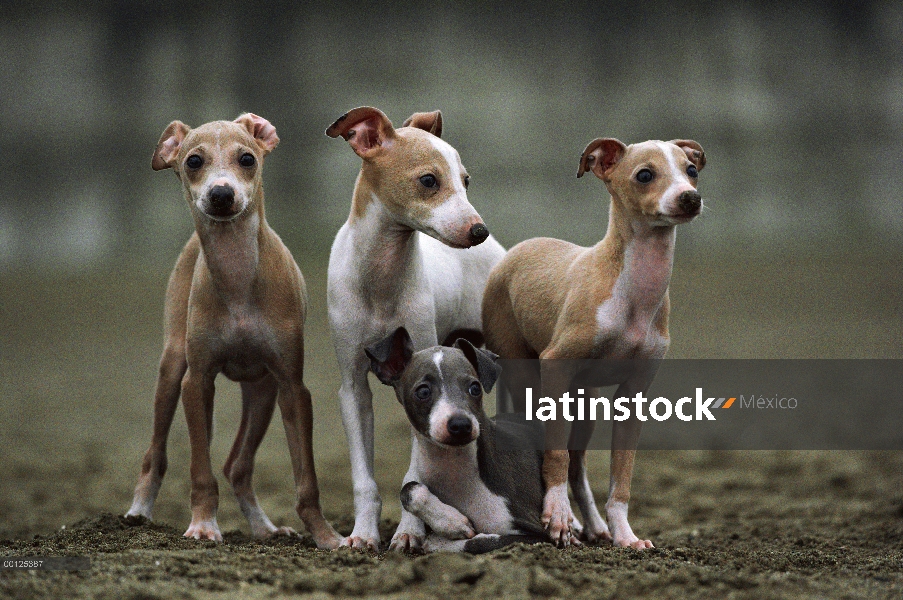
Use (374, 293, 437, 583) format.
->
(424, 136, 479, 246)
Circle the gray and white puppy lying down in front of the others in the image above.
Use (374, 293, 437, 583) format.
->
(366, 327, 550, 554)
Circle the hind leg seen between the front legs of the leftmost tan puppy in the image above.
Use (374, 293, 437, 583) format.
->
(223, 374, 294, 538)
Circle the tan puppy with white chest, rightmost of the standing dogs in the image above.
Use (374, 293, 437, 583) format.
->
(483, 138, 705, 549)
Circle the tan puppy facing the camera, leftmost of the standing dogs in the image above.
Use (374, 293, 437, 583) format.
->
(128, 114, 341, 548)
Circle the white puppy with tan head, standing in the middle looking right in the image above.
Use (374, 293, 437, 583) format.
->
(326, 107, 505, 550)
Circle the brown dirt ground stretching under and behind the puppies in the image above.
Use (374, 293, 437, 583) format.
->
(0, 251, 903, 600)
